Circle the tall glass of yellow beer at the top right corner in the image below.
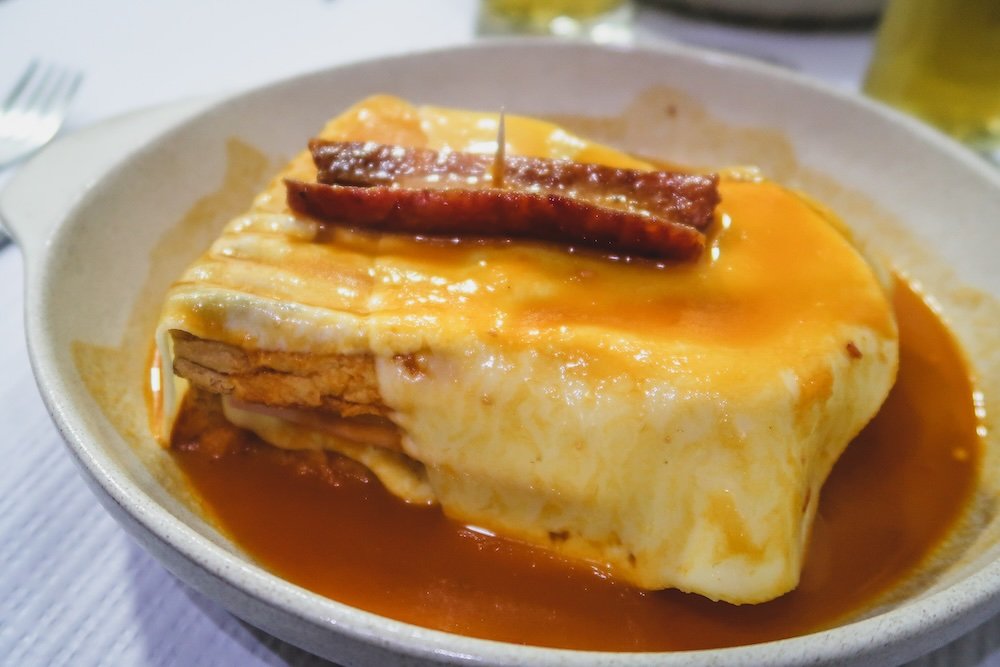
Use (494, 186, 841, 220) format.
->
(864, 0, 1000, 159)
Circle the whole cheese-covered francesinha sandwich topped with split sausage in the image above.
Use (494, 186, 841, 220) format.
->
(157, 97, 898, 603)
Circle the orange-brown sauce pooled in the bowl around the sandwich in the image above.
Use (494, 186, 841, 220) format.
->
(173, 282, 980, 651)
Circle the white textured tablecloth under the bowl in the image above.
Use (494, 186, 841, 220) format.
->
(0, 0, 1000, 666)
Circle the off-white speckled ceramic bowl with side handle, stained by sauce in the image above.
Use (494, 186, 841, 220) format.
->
(0, 41, 1000, 667)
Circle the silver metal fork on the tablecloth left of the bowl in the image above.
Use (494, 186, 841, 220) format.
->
(0, 60, 83, 248)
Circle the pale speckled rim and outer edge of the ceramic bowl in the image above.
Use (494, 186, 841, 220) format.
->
(19, 39, 1000, 667)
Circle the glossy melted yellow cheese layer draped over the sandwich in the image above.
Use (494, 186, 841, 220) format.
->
(159, 97, 898, 602)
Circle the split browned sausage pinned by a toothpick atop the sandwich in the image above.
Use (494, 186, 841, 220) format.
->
(285, 140, 719, 260)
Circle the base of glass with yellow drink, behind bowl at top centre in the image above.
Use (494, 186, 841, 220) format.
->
(479, 0, 632, 44)
